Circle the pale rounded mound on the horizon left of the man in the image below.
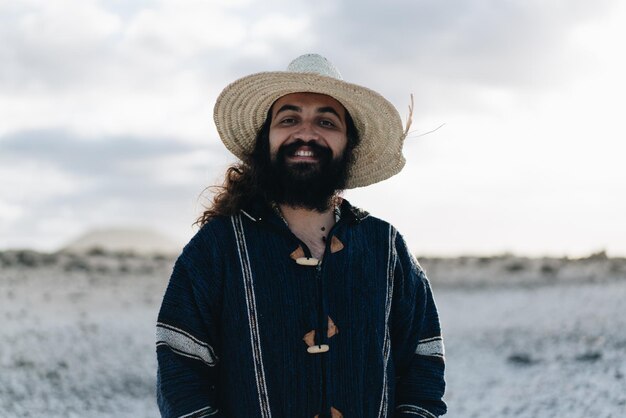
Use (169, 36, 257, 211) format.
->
(62, 228, 181, 254)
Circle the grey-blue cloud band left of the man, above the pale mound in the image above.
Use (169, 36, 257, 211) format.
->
(0, 130, 228, 249)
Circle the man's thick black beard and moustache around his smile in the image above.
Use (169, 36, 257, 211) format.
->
(264, 140, 350, 212)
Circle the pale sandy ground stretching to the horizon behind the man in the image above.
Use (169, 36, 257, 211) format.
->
(0, 252, 626, 418)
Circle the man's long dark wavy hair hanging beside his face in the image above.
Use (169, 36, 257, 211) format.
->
(194, 108, 359, 226)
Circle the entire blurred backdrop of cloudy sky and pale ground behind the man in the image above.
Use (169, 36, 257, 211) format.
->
(0, 0, 626, 417)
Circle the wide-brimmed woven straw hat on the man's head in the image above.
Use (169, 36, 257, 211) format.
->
(213, 54, 411, 189)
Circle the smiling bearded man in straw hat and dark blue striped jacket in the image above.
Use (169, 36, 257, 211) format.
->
(157, 54, 446, 418)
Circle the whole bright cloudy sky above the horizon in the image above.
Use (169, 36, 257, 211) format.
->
(0, 0, 626, 256)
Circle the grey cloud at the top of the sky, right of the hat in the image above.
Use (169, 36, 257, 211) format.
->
(325, 0, 616, 88)
